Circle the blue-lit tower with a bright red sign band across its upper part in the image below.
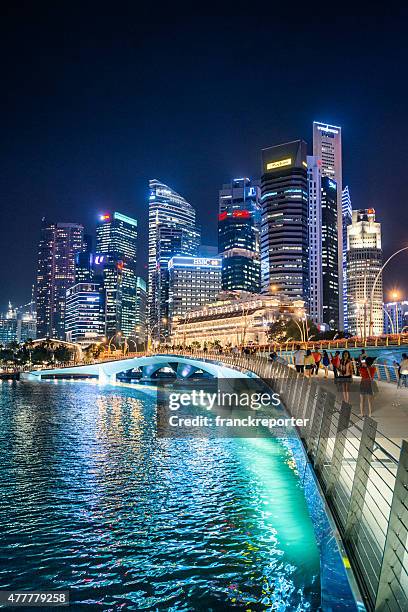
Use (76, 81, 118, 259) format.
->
(218, 178, 261, 293)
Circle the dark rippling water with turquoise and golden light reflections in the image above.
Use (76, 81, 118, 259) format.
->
(0, 382, 320, 611)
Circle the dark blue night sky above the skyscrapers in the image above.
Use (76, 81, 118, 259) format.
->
(0, 8, 408, 311)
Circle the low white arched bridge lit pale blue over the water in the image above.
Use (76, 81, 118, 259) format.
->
(29, 354, 242, 383)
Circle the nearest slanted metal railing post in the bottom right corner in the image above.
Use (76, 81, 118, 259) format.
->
(375, 440, 408, 610)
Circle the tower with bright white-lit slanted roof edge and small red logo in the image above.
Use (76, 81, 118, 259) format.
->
(96, 212, 137, 337)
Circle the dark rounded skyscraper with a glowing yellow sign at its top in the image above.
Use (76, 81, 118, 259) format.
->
(261, 140, 309, 302)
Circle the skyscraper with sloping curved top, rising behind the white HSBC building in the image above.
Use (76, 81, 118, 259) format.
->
(148, 179, 200, 340)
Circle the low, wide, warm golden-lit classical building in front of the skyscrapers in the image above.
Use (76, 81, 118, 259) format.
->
(171, 291, 305, 347)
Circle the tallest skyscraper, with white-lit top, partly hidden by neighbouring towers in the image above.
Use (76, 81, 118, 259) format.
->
(313, 121, 344, 329)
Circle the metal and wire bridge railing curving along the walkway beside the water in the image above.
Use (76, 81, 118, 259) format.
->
(168, 351, 408, 612)
